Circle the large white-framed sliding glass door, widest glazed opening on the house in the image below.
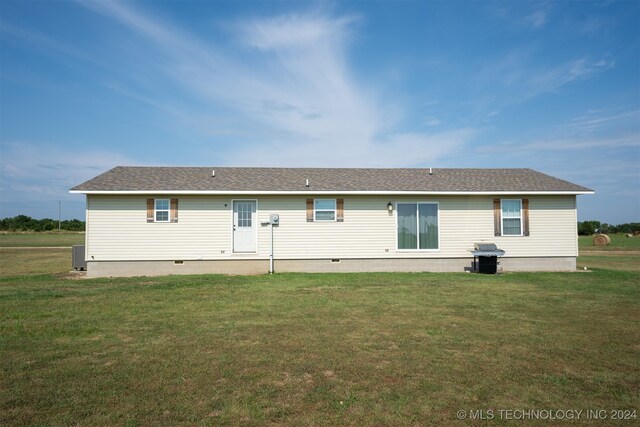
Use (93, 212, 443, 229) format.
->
(396, 203, 439, 250)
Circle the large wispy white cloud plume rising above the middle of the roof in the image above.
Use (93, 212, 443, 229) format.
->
(77, 2, 471, 166)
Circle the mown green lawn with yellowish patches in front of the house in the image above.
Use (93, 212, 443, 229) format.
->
(0, 249, 640, 426)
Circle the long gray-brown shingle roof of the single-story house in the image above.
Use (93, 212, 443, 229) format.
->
(71, 166, 591, 193)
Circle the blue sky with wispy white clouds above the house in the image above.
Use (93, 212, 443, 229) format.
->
(0, 1, 640, 224)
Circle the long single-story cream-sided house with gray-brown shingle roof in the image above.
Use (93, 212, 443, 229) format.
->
(71, 167, 593, 277)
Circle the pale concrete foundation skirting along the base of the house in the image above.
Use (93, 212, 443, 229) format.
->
(87, 257, 576, 277)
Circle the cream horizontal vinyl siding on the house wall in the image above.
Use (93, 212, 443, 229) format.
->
(86, 194, 577, 262)
